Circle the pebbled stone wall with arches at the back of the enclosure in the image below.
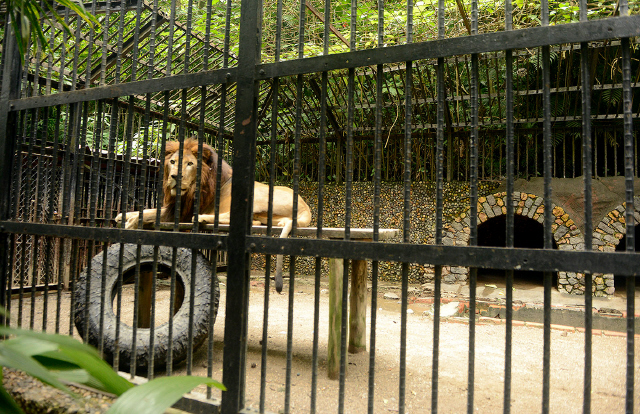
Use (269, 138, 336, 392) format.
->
(253, 179, 640, 296)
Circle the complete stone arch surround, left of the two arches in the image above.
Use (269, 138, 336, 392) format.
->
(442, 192, 584, 293)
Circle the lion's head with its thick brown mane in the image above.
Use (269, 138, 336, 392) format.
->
(162, 139, 233, 222)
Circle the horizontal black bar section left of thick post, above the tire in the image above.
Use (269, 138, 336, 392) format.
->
(0, 221, 227, 250)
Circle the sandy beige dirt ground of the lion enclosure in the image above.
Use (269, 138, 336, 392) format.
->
(6, 277, 640, 414)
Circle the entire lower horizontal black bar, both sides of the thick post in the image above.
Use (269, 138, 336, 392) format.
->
(6, 221, 640, 276)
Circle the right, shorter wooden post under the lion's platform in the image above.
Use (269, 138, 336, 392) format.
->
(349, 260, 367, 354)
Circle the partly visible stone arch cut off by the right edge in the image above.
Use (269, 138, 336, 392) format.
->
(592, 197, 640, 295)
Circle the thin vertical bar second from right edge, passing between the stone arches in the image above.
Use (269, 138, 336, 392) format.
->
(580, 0, 593, 414)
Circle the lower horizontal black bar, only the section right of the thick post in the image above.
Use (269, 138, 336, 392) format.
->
(247, 236, 640, 276)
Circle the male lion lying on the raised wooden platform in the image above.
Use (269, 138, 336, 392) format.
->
(116, 139, 311, 292)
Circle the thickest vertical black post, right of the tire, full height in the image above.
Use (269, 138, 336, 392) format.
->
(222, 2, 261, 413)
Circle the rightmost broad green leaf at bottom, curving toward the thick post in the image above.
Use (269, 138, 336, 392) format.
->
(107, 376, 226, 414)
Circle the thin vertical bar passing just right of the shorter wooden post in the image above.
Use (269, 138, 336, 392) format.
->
(370, 0, 385, 414)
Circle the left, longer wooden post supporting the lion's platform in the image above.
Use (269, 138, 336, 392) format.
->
(327, 258, 344, 379)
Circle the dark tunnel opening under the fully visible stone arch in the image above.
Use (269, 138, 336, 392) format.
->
(478, 215, 558, 286)
